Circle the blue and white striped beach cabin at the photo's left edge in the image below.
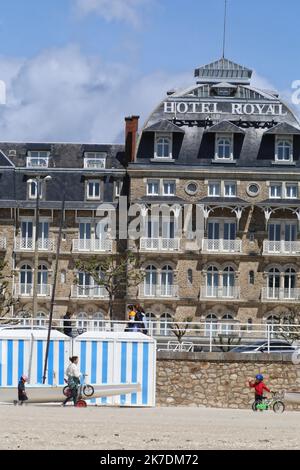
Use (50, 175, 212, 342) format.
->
(0, 328, 71, 387)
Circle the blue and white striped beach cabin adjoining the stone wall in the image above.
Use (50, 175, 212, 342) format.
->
(73, 332, 156, 407)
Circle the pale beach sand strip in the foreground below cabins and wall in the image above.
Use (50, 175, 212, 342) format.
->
(0, 405, 300, 450)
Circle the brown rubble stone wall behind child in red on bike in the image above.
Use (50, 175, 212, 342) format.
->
(157, 351, 300, 410)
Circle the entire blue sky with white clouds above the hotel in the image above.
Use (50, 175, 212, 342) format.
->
(0, 0, 300, 143)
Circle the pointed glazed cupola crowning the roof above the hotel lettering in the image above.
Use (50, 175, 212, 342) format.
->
(195, 57, 252, 83)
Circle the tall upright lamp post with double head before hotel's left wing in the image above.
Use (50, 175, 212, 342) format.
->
(28, 175, 52, 318)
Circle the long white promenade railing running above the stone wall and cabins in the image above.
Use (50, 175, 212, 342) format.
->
(0, 316, 300, 354)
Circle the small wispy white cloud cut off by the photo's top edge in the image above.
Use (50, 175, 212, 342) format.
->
(75, 0, 153, 27)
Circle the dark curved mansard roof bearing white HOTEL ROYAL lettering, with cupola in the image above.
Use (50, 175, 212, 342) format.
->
(134, 58, 300, 171)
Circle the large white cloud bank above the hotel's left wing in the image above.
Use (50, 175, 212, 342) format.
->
(0, 46, 189, 143)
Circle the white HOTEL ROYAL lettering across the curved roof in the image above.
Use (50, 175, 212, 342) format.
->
(164, 101, 287, 116)
